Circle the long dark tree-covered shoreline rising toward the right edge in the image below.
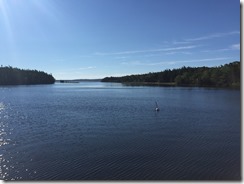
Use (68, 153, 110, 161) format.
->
(102, 61, 240, 87)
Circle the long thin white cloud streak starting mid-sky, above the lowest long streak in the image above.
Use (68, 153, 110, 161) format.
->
(95, 45, 198, 56)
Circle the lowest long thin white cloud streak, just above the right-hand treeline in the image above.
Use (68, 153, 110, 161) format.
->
(121, 57, 230, 66)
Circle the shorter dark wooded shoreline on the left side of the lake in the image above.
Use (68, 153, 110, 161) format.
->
(0, 66, 55, 85)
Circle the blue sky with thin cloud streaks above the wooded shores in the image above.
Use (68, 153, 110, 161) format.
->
(0, 0, 240, 79)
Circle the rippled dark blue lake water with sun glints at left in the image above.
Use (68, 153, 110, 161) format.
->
(0, 82, 241, 180)
